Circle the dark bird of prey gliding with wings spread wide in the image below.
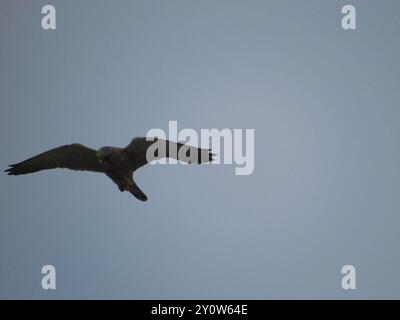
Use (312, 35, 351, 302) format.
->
(5, 137, 215, 201)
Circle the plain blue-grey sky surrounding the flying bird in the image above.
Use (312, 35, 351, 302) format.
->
(0, 0, 400, 299)
